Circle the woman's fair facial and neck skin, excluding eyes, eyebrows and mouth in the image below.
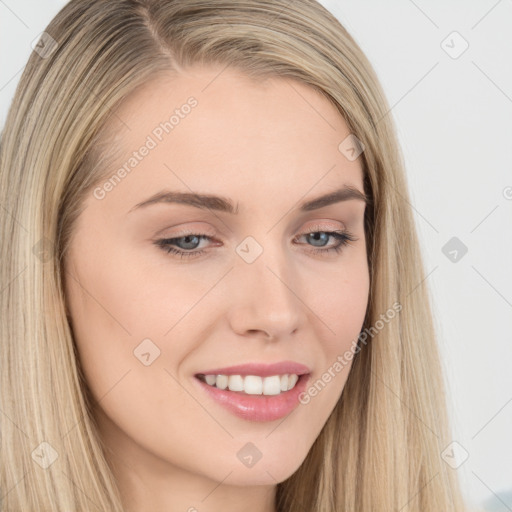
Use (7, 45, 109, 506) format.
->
(65, 66, 369, 512)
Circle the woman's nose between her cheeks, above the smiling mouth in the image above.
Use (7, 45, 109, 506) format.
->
(227, 246, 305, 340)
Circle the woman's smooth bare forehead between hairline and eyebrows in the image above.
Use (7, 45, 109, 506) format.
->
(92, 67, 363, 216)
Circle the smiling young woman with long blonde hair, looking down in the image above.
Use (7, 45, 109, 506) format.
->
(0, 0, 463, 512)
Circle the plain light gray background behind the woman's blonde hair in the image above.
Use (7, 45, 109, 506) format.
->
(0, 0, 512, 511)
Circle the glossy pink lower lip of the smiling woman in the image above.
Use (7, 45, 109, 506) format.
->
(194, 374, 310, 421)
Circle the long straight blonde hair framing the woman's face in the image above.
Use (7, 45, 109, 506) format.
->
(0, 0, 463, 512)
